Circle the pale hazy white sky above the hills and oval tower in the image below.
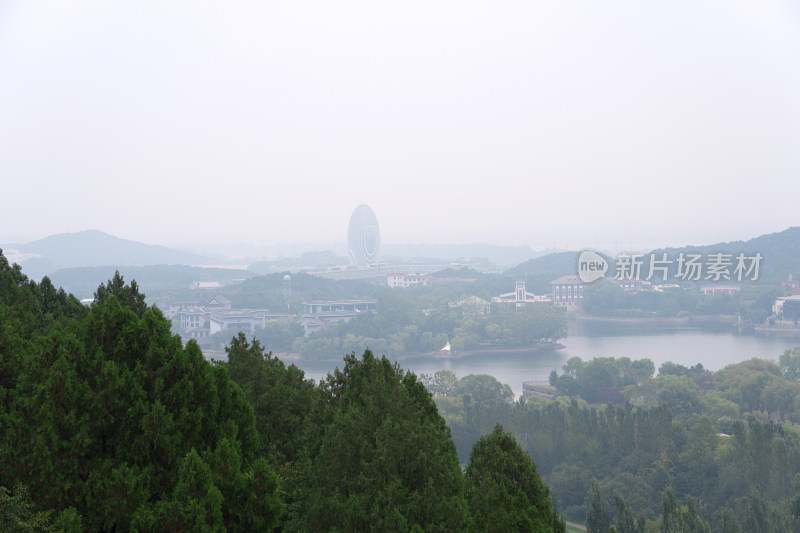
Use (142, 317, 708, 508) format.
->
(0, 0, 800, 248)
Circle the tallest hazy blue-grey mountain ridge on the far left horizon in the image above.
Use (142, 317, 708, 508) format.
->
(3, 230, 211, 279)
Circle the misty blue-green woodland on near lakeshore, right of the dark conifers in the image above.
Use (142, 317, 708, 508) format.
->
(427, 356, 800, 533)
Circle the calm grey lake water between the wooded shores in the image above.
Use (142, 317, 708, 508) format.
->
(294, 322, 800, 396)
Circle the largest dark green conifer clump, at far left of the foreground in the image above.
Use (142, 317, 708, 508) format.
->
(0, 260, 281, 531)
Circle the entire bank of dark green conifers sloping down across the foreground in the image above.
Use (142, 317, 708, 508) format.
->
(0, 250, 565, 532)
